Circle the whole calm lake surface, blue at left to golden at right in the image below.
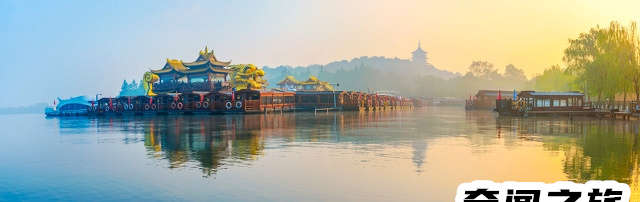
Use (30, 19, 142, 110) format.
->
(0, 107, 640, 201)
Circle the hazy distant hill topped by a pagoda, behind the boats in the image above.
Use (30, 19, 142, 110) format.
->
(263, 44, 535, 99)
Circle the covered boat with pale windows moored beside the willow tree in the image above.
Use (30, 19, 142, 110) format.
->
(517, 91, 584, 111)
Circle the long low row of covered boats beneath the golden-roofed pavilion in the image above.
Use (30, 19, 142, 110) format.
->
(46, 90, 414, 116)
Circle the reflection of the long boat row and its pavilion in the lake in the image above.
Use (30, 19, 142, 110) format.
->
(81, 111, 416, 177)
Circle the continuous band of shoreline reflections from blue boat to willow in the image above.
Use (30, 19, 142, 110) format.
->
(59, 109, 640, 184)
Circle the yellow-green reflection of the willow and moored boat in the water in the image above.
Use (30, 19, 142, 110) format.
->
(496, 118, 640, 198)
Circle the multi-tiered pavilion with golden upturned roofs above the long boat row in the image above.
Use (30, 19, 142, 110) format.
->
(151, 47, 232, 93)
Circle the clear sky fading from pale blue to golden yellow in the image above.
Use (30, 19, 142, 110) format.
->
(0, 0, 640, 107)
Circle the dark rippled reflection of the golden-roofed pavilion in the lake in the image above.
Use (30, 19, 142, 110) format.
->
(143, 116, 276, 176)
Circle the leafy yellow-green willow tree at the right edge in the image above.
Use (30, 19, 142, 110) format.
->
(563, 21, 640, 101)
